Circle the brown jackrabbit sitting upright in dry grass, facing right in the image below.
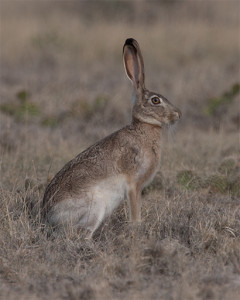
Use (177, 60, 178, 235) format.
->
(42, 38, 181, 237)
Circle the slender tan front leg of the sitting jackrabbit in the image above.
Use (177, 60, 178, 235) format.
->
(128, 188, 142, 223)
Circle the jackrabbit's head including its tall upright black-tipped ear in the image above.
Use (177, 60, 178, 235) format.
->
(123, 38, 181, 126)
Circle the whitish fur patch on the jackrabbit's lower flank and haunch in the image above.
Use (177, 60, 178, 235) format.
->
(48, 175, 127, 230)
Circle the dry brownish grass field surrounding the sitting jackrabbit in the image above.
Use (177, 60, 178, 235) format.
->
(0, 1, 240, 299)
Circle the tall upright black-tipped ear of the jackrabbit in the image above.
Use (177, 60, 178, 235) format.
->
(123, 38, 144, 90)
